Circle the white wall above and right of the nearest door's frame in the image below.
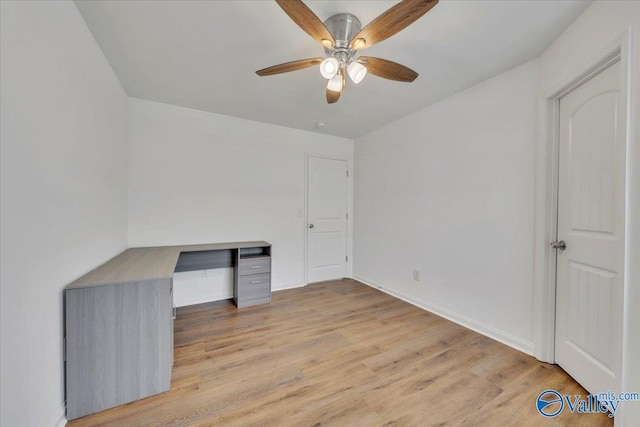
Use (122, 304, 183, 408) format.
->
(536, 0, 640, 426)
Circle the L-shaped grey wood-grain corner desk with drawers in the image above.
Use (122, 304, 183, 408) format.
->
(64, 241, 271, 420)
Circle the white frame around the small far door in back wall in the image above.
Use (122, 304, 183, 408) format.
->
(302, 153, 353, 286)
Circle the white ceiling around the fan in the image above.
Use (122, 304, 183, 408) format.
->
(76, 0, 590, 138)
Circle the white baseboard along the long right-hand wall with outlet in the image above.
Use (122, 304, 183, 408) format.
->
(352, 275, 533, 356)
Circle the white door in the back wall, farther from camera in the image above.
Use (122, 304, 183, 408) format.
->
(307, 157, 348, 283)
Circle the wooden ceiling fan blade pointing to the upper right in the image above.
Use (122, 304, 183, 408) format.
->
(350, 0, 438, 50)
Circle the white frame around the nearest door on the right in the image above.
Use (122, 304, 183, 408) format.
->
(533, 30, 632, 372)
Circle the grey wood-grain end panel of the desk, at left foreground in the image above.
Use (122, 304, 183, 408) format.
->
(65, 279, 173, 420)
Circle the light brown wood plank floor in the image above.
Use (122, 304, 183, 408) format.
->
(67, 280, 612, 427)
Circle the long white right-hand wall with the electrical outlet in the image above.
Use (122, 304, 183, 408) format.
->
(353, 60, 539, 352)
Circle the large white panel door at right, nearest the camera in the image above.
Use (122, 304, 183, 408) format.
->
(555, 62, 625, 393)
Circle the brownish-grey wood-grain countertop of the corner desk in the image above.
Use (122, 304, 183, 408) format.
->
(66, 241, 271, 289)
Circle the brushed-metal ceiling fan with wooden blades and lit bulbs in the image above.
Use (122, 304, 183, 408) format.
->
(256, 0, 438, 104)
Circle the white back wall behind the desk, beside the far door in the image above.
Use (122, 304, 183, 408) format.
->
(129, 99, 353, 303)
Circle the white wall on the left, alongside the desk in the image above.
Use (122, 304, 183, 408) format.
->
(0, 1, 127, 427)
